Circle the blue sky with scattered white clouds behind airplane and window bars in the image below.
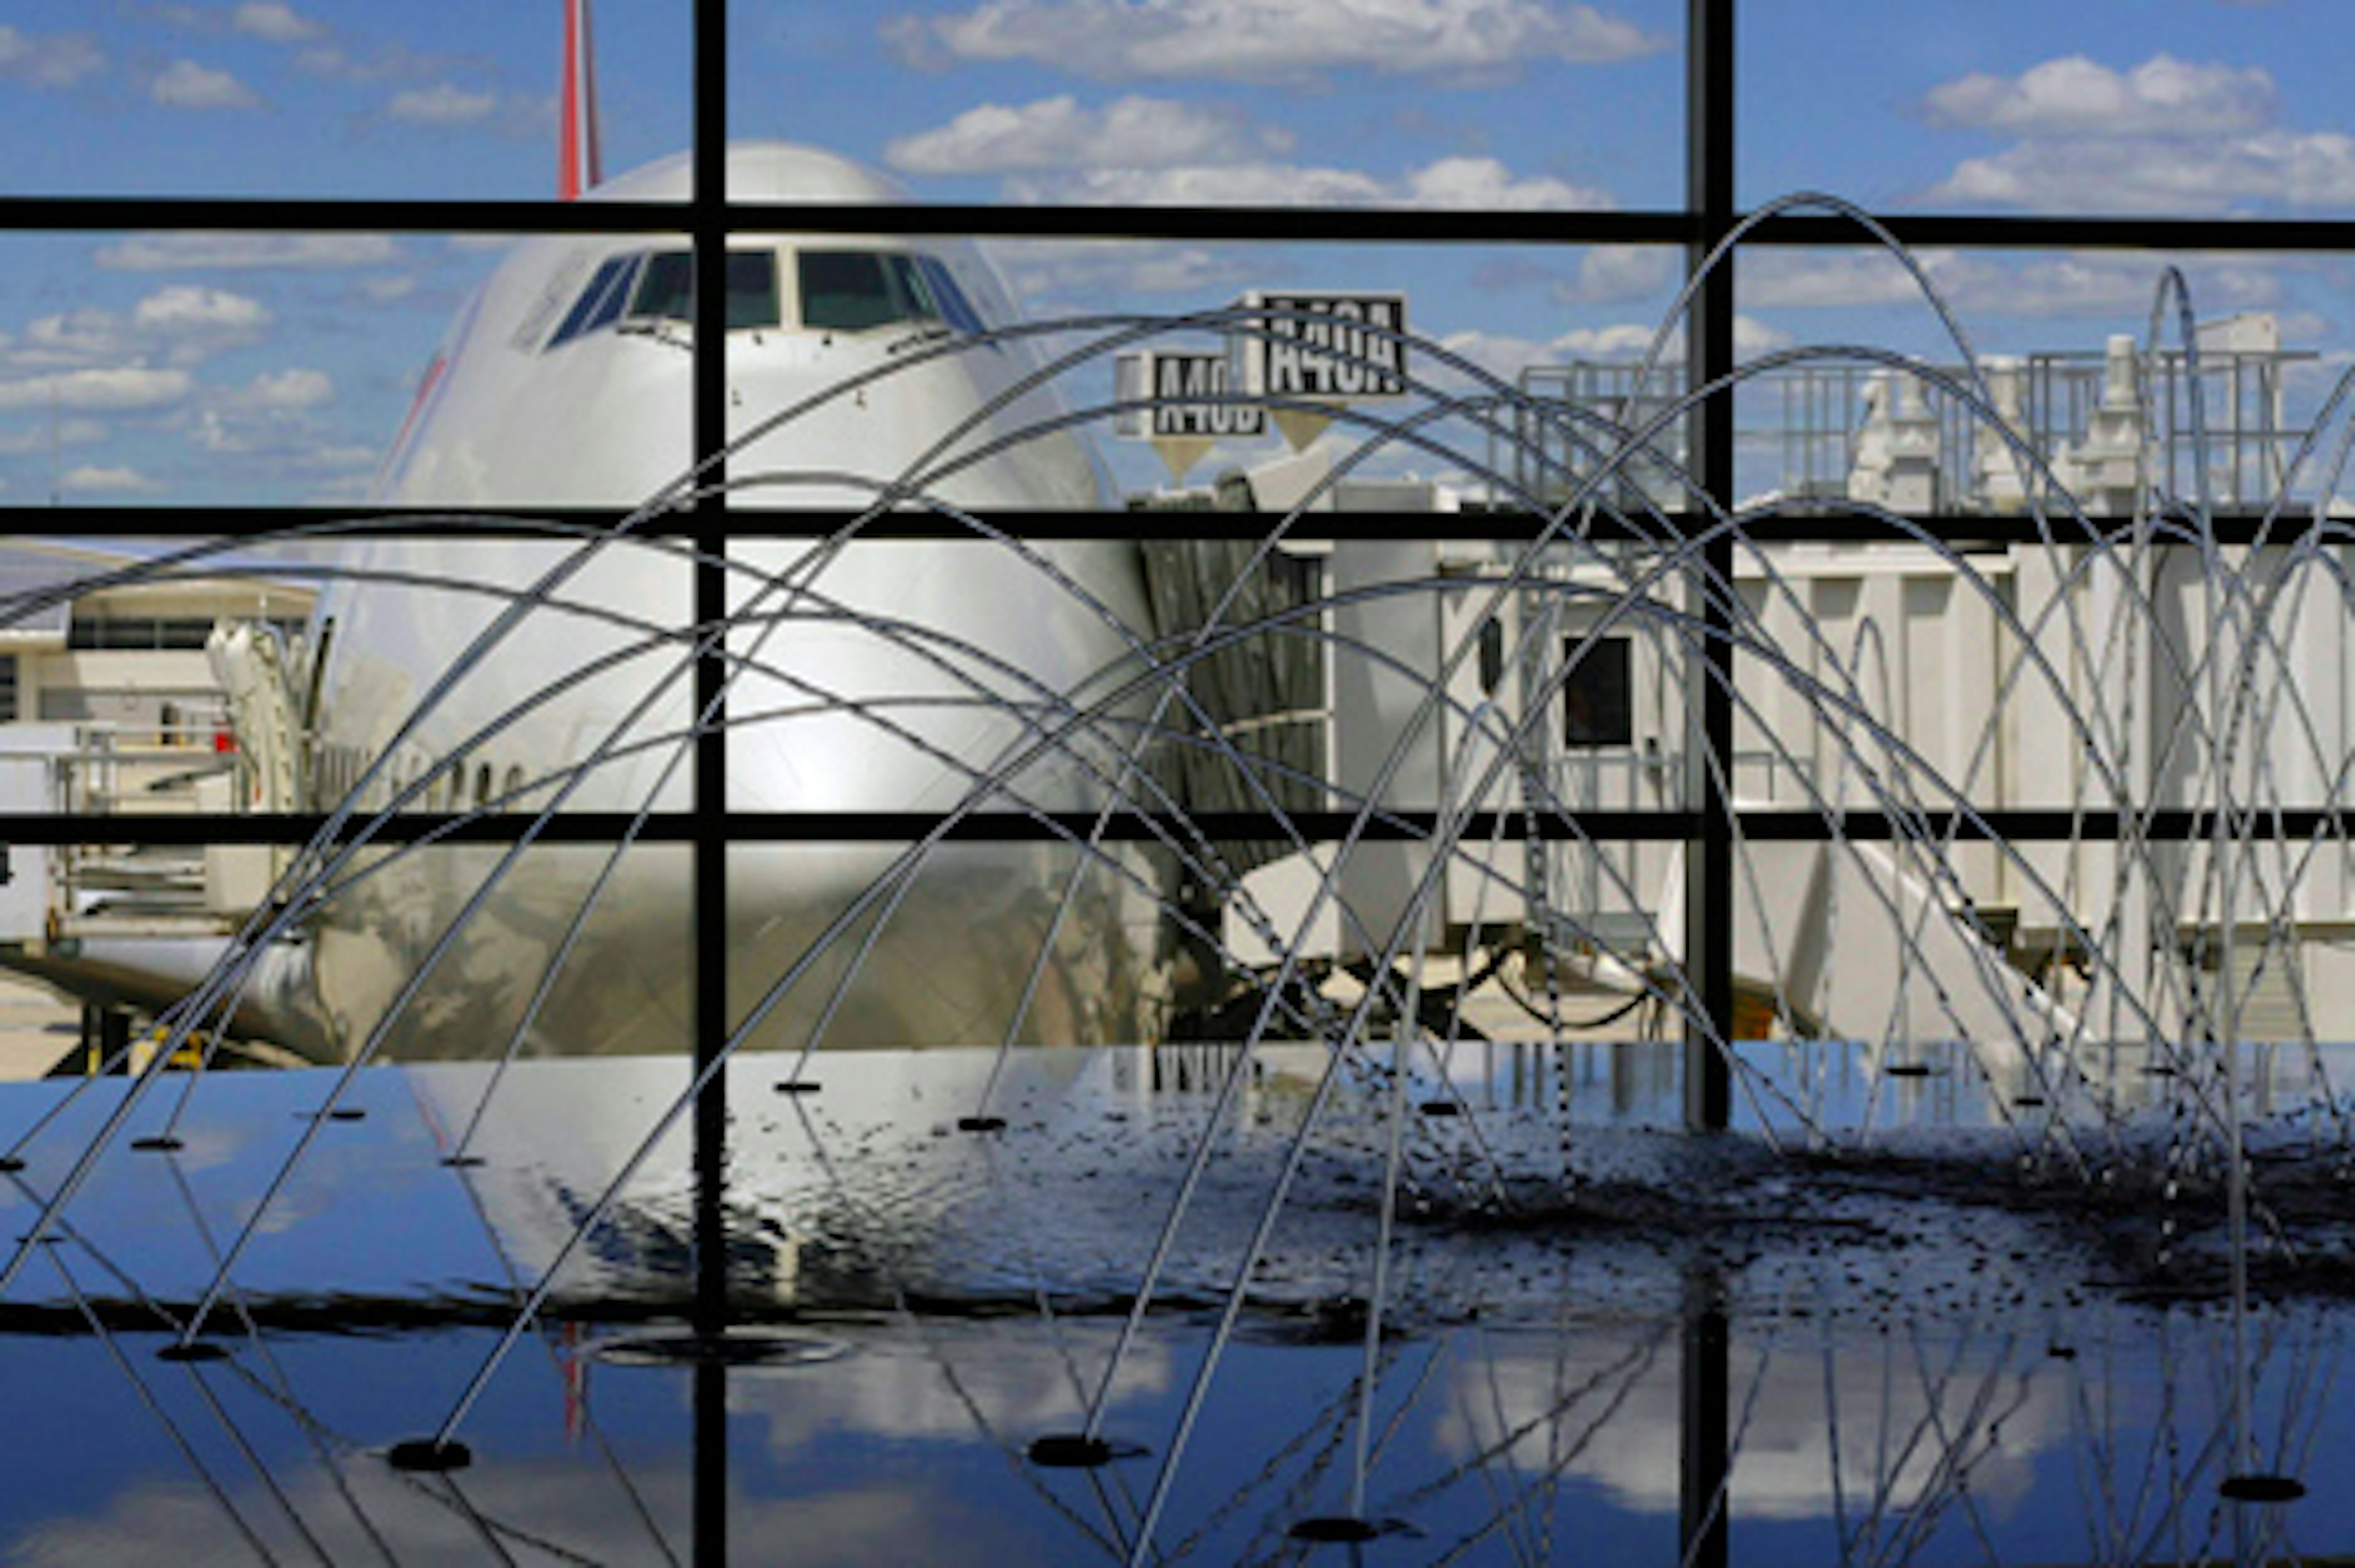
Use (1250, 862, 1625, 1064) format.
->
(0, 0, 2355, 504)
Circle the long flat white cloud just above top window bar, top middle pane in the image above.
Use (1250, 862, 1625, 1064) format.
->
(1006, 158, 1611, 212)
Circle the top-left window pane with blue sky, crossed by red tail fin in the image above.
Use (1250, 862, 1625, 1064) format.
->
(0, 0, 692, 200)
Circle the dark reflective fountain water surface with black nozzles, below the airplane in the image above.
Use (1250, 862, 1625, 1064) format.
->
(0, 1048, 2355, 1566)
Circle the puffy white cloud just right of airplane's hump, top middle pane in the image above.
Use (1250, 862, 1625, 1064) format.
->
(883, 96, 1290, 174)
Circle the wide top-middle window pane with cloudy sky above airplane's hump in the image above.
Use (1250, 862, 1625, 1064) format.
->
(730, 0, 1686, 210)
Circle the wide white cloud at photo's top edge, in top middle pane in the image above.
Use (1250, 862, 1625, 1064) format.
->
(883, 0, 1668, 80)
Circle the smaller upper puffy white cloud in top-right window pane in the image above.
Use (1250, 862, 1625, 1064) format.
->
(1926, 54, 2275, 137)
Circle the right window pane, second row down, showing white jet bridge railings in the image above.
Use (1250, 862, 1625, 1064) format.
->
(1738, 247, 2346, 511)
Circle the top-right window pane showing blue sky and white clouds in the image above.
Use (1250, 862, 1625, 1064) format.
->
(1738, 0, 2355, 216)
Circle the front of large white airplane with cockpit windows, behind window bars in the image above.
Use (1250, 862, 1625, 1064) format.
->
(313, 143, 1154, 1055)
